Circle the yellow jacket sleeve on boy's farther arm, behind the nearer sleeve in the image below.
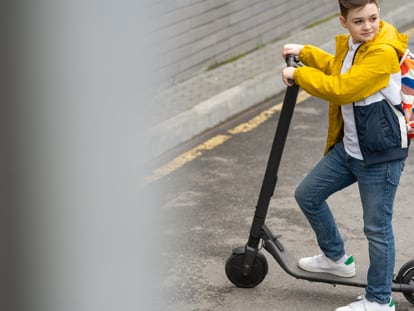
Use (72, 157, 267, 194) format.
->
(299, 45, 334, 74)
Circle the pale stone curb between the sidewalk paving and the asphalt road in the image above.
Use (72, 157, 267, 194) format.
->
(147, 65, 285, 160)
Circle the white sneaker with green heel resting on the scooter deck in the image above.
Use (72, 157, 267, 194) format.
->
(298, 255, 356, 278)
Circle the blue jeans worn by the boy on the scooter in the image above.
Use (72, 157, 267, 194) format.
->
(295, 142, 404, 304)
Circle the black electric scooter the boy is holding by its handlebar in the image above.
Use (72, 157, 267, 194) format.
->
(225, 55, 414, 304)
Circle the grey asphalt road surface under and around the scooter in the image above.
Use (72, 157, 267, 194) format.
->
(153, 93, 414, 311)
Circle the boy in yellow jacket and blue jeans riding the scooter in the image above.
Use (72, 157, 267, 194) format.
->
(282, 0, 409, 311)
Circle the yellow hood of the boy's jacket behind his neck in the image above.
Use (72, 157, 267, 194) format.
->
(337, 20, 408, 55)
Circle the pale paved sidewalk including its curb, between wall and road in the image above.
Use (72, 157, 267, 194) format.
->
(146, 0, 414, 157)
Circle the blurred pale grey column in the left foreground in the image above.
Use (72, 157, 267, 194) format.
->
(8, 0, 162, 311)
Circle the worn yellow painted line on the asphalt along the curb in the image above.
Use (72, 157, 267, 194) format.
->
(144, 91, 310, 184)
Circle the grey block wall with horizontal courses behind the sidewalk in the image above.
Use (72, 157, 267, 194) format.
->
(152, 0, 338, 86)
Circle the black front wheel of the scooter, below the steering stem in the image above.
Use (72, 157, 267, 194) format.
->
(225, 248, 268, 288)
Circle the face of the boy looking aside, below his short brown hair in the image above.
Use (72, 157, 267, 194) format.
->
(339, 3, 380, 43)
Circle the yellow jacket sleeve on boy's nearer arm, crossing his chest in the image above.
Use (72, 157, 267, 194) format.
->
(294, 45, 400, 105)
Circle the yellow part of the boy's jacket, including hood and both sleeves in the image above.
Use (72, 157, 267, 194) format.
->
(294, 21, 408, 158)
